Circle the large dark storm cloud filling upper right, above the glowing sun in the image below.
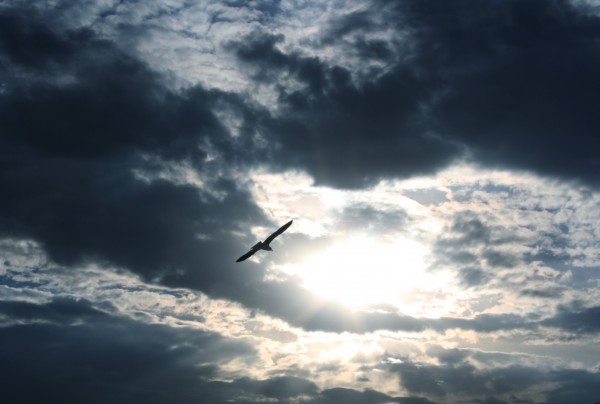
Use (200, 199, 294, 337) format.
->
(229, 0, 600, 187)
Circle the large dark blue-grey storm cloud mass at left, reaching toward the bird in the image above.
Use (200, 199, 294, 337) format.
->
(0, 10, 266, 289)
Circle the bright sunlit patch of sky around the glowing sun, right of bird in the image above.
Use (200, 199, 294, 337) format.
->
(244, 166, 600, 324)
